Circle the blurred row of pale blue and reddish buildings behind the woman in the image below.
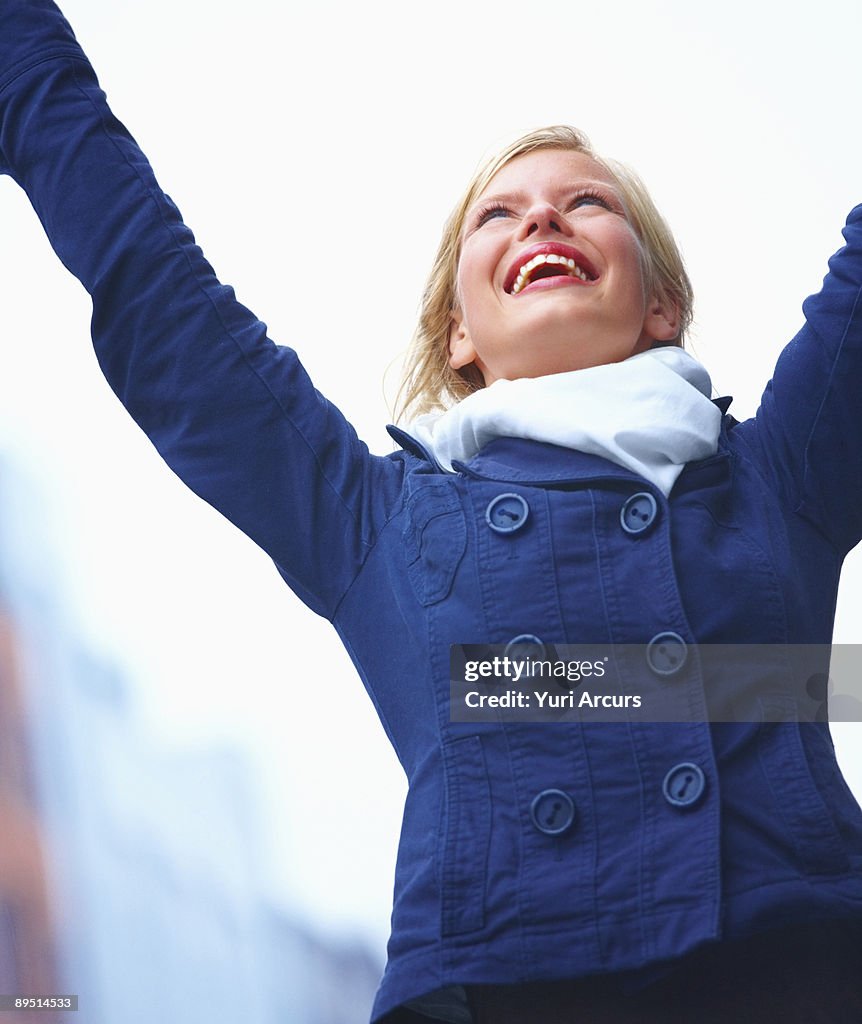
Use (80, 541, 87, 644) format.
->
(0, 464, 381, 1024)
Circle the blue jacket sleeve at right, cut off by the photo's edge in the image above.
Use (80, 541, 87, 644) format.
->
(736, 206, 862, 554)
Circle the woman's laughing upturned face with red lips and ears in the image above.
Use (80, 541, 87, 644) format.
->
(449, 150, 679, 385)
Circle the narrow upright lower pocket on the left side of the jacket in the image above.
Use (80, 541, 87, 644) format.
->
(441, 736, 491, 935)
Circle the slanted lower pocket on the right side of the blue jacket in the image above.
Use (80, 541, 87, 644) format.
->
(760, 696, 851, 874)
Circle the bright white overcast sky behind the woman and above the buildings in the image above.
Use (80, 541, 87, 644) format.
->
(0, 0, 862, 942)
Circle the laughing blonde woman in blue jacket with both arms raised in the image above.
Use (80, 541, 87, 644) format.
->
(0, 0, 862, 1024)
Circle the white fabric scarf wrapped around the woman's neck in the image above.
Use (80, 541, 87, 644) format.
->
(406, 346, 722, 496)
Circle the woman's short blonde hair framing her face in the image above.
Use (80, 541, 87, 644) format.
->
(396, 125, 694, 420)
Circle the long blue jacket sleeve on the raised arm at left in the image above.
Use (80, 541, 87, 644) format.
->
(0, 0, 397, 617)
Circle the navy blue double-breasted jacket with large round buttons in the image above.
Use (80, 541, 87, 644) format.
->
(0, 0, 862, 1018)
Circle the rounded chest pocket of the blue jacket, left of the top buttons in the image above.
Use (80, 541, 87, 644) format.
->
(403, 483, 467, 605)
